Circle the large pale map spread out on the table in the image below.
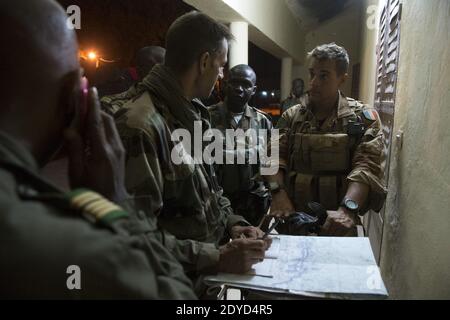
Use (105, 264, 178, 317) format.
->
(205, 235, 388, 299)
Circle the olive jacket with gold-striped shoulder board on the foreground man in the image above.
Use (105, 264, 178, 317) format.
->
(0, 132, 195, 299)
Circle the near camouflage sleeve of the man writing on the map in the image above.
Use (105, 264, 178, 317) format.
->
(118, 123, 223, 272)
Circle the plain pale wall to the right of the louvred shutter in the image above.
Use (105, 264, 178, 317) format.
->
(381, 0, 450, 299)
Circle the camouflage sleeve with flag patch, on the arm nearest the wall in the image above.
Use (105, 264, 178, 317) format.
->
(347, 108, 386, 211)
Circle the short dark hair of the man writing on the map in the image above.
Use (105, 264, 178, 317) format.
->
(165, 11, 233, 72)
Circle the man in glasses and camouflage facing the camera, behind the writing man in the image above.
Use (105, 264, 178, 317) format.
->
(208, 64, 272, 225)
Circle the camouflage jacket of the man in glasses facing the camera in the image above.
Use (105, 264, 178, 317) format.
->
(208, 102, 272, 197)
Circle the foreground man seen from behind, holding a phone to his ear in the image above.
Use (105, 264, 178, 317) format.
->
(0, 0, 195, 299)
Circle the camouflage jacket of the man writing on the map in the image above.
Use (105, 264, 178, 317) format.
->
(116, 79, 248, 276)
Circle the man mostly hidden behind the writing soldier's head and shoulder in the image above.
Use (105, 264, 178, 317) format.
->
(100, 46, 166, 116)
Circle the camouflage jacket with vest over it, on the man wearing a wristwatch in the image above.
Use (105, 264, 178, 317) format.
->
(277, 93, 386, 211)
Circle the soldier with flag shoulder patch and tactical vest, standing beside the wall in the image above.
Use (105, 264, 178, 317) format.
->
(268, 43, 386, 236)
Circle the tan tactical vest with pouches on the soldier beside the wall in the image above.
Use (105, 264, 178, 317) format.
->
(286, 99, 365, 211)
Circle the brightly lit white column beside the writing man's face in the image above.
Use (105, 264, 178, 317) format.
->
(229, 21, 248, 69)
